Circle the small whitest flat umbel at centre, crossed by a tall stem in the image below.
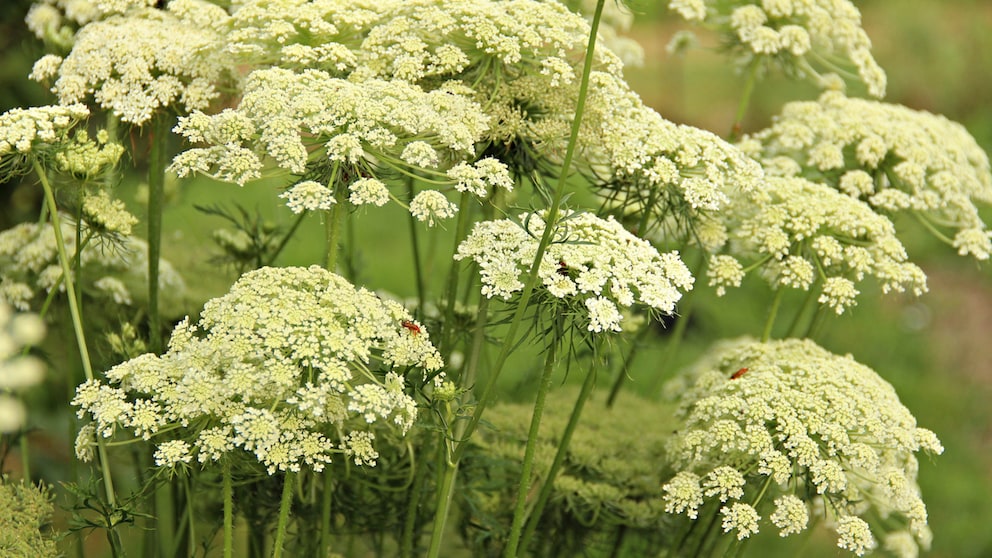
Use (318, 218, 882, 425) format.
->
(455, 213, 693, 333)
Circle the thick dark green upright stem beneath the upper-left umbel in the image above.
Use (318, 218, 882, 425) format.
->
(148, 115, 169, 353)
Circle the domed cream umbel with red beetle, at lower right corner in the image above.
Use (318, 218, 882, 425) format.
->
(664, 339, 943, 556)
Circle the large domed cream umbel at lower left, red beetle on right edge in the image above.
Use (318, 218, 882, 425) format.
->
(73, 266, 443, 474)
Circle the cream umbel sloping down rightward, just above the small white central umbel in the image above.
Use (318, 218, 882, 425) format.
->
(580, 72, 764, 240)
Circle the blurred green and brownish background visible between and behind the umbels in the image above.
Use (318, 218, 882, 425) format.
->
(0, 0, 992, 558)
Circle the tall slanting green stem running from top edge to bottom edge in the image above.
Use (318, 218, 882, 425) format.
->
(428, 0, 606, 558)
